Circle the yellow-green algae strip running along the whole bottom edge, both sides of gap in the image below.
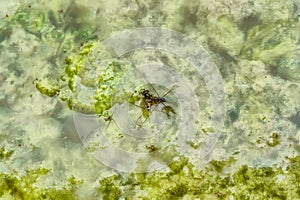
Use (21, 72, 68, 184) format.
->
(0, 157, 300, 200)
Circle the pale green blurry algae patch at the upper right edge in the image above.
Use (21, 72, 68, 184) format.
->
(240, 20, 299, 64)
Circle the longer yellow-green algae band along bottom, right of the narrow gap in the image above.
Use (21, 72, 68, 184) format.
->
(95, 157, 300, 199)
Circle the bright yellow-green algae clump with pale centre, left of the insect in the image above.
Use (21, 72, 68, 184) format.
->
(35, 39, 131, 116)
